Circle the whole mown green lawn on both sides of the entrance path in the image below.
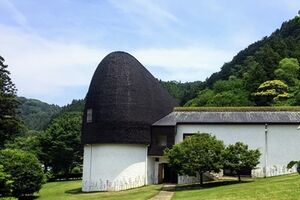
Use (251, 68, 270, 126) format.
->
(0, 174, 300, 200)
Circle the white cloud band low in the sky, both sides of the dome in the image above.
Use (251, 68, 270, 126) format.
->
(0, 23, 237, 104)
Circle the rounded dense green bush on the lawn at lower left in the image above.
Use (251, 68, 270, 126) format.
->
(0, 149, 44, 197)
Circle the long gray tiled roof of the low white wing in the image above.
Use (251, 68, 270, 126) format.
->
(153, 111, 300, 126)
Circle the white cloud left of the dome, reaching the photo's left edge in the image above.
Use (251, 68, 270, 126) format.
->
(0, 26, 107, 99)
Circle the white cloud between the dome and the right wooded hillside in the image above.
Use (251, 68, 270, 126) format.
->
(133, 46, 235, 81)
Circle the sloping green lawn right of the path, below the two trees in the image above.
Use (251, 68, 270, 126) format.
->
(172, 174, 300, 200)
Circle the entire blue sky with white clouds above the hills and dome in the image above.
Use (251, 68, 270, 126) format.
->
(0, 0, 300, 106)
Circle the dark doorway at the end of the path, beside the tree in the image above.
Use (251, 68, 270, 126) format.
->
(158, 163, 178, 183)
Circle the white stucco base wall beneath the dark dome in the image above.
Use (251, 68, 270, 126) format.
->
(82, 144, 151, 192)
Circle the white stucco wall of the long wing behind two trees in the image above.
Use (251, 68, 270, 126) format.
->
(175, 124, 300, 177)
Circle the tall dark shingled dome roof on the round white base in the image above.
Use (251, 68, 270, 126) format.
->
(82, 52, 177, 144)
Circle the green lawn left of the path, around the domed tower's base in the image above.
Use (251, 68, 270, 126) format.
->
(37, 181, 161, 200)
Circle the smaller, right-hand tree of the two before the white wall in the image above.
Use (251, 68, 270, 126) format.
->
(223, 142, 261, 182)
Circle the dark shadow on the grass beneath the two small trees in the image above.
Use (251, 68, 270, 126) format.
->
(175, 180, 253, 191)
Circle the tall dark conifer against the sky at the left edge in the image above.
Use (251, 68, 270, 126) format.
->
(0, 56, 23, 149)
